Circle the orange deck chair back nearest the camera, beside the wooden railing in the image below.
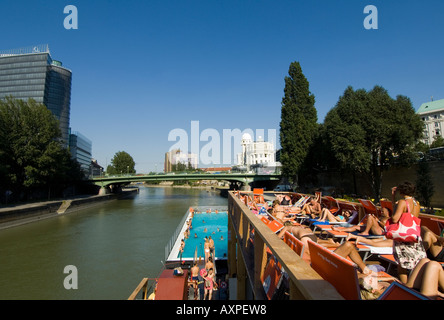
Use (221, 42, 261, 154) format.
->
(308, 240, 361, 300)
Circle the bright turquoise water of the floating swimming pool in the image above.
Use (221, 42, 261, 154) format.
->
(182, 212, 228, 259)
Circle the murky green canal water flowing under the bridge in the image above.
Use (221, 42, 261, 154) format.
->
(0, 187, 227, 300)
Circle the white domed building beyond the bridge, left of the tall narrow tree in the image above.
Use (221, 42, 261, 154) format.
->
(237, 133, 276, 167)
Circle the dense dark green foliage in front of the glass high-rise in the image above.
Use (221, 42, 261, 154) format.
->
(0, 97, 81, 198)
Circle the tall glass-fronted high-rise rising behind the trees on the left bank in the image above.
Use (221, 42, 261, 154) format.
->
(0, 45, 72, 146)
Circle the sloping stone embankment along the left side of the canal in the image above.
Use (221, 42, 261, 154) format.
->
(0, 188, 139, 230)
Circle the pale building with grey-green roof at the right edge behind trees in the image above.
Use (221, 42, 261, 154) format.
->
(417, 99, 444, 146)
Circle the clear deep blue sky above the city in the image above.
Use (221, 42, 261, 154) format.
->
(0, 0, 444, 172)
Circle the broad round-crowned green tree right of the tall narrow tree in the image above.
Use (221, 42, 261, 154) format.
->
(324, 86, 423, 201)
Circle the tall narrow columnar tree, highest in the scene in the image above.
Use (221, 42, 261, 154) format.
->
(280, 62, 317, 183)
